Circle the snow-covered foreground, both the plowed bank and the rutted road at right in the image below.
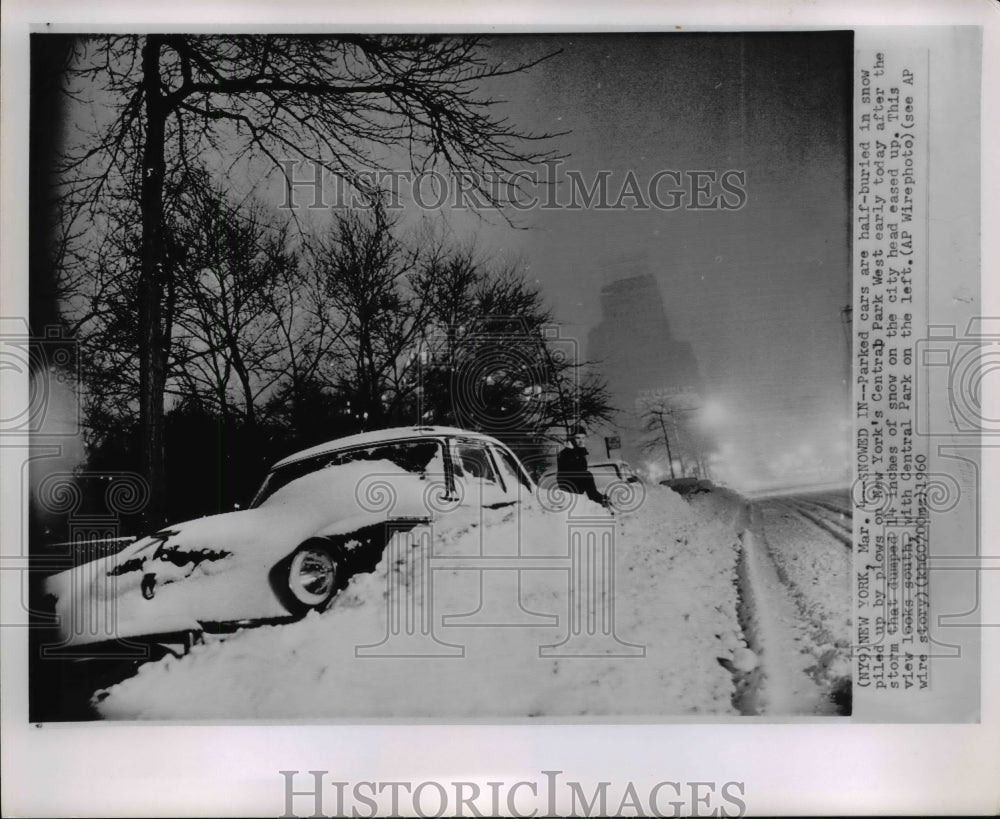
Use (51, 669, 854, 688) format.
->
(86, 486, 850, 719)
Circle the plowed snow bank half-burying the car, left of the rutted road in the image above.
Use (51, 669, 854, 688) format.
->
(95, 487, 753, 719)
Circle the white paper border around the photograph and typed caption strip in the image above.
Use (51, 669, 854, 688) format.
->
(0, 0, 1000, 816)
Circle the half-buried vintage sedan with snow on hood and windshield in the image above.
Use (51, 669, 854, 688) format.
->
(45, 427, 535, 645)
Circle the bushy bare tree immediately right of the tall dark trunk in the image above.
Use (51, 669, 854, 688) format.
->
(166, 180, 316, 426)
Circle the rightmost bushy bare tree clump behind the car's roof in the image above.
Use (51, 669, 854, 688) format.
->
(414, 242, 614, 441)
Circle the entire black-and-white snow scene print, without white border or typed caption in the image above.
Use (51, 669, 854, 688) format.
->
(21, 31, 853, 722)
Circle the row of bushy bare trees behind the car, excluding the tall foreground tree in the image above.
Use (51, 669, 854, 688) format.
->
(41, 181, 611, 537)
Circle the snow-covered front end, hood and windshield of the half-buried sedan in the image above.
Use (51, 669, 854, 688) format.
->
(45, 461, 435, 643)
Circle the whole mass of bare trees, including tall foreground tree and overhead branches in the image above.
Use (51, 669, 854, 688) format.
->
(32, 34, 610, 534)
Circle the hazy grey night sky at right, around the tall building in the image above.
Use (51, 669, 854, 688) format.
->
(464, 33, 853, 486)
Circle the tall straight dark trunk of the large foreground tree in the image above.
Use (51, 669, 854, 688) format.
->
(139, 35, 167, 529)
